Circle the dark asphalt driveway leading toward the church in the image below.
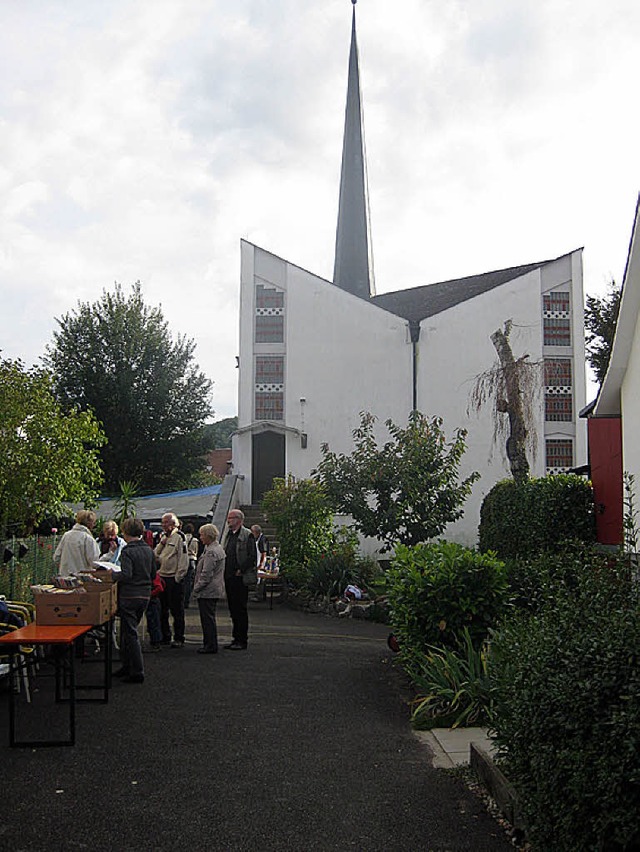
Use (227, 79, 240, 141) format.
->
(0, 604, 512, 852)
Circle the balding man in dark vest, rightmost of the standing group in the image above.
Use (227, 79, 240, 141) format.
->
(224, 509, 257, 651)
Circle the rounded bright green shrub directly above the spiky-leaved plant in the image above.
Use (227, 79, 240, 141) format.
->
(387, 541, 507, 653)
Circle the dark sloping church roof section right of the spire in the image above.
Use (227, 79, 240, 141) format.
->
(371, 258, 572, 322)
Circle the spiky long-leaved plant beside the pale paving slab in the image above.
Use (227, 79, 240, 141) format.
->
(407, 627, 491, 730)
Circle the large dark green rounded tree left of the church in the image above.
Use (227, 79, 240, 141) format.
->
(45, 282, 211, 494)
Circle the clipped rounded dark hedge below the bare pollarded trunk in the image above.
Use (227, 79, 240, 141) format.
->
(479, 474, 595, 559)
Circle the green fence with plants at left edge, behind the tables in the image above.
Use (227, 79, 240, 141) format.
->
(0, 535, 60, 601)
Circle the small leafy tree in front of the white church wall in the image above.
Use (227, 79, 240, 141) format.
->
(314, 411, 479, 550)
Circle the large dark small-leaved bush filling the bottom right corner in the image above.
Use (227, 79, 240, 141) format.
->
(490, 560, 640, 852)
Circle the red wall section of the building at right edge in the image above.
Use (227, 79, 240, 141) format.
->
(587, 417, 623, 544)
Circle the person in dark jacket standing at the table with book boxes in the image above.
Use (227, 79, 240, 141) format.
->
(115, 518, 156, 683)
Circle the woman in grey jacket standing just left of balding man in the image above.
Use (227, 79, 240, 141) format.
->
(193, 524, 226, 654)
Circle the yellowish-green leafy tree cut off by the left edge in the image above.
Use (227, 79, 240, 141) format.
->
(0, 360, 105, 536)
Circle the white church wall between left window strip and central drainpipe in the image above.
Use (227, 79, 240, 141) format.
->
(285, 266, 411, 466)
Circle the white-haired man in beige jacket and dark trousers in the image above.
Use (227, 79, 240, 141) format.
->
(154, 512, 189, 648)
